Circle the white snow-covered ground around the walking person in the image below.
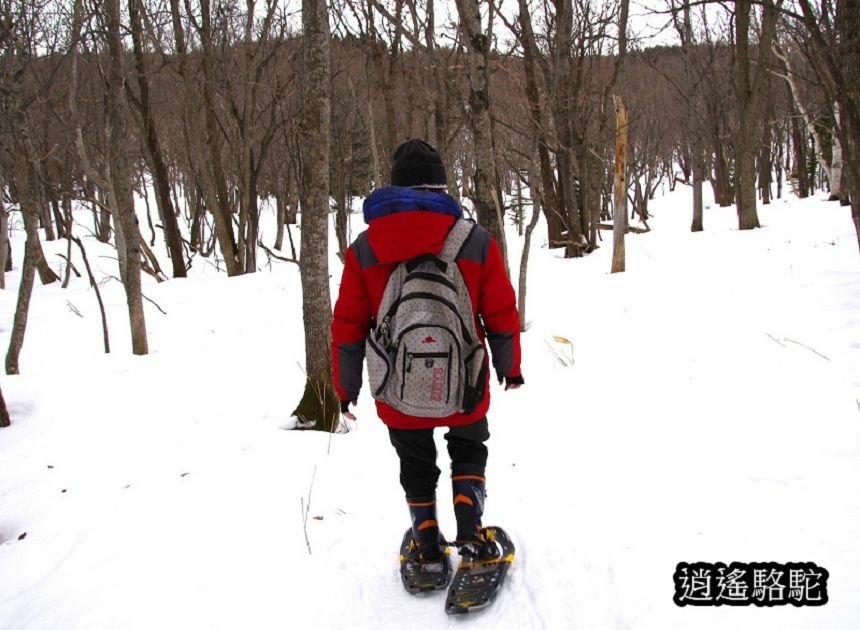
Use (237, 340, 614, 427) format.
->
(0, 189, 860, 630)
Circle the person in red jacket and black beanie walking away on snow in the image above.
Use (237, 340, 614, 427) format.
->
(332, 140, 524, 580)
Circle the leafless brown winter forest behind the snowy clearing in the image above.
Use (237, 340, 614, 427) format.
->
(0, 0, 860, 428)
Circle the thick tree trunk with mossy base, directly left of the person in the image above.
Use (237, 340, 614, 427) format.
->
(293, 0, 340, 431)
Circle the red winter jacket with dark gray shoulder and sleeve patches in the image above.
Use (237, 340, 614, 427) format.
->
(331, 189, 521, 429)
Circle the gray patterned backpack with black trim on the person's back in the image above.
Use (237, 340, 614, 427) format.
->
(366, 219, 488, 418)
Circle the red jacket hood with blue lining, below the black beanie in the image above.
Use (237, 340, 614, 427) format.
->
(364, 186, 463, 263)
